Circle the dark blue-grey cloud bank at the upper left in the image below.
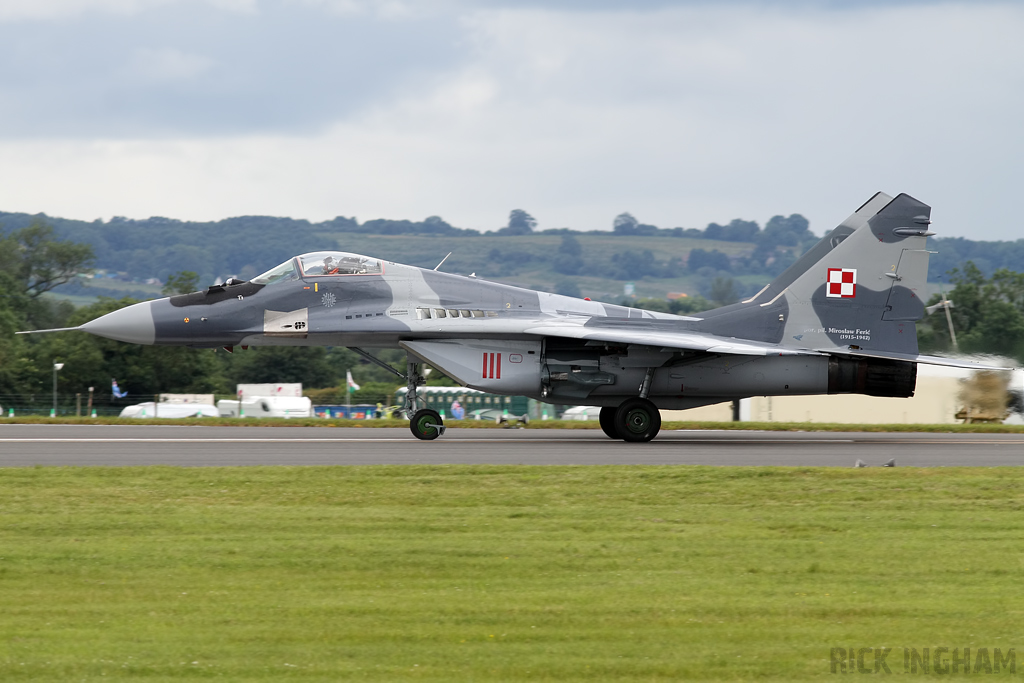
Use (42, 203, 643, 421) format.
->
(0, 2, 462, 139)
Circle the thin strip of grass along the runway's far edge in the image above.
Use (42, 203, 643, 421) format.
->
(0, 416, 1024, 434)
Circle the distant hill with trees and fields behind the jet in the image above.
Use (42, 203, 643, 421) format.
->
(0, 210, 1024, 301)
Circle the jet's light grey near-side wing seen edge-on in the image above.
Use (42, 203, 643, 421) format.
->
(523, 321, 825, 355)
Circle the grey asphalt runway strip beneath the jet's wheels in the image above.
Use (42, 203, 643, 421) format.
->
(0, 425, 1024, 467)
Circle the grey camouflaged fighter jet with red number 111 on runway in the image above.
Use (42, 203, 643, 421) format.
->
(18, 193, 999, 441)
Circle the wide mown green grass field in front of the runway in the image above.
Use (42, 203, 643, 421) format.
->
(0, 466, 1024, 681)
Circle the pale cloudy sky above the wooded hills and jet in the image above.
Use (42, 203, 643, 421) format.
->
(0, 0, 1024, 240)
